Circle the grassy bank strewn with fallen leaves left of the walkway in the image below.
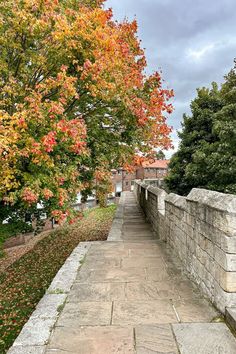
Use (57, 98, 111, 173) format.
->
(0, 205, 116, 354)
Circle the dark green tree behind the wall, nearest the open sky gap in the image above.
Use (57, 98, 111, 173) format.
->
(166, 83, 222, 195)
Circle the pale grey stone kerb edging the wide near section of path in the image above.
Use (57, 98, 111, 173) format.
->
(7, 241, 91, 354)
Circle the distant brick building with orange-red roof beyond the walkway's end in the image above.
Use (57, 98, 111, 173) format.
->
(111, 160, 169, 194)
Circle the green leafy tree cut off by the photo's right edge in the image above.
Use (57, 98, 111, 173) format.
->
(202, 63, 236, 194)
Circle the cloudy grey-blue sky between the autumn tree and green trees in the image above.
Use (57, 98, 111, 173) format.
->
(106, 0, 236, 155)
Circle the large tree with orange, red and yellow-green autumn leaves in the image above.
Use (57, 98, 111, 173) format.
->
(0, 0, 173, 220)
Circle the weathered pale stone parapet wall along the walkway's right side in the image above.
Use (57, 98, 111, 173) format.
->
(134, 182, 236, 312)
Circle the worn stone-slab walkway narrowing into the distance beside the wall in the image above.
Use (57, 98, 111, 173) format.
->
(46, 193, 236, 354)
